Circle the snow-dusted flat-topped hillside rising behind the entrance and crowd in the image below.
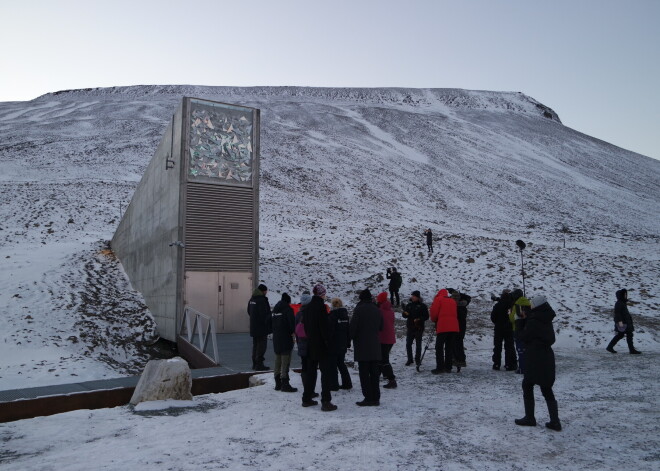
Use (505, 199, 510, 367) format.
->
(0, 86, 660, 389)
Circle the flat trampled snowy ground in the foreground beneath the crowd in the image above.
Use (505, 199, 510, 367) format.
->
(0, 339, 660, 471)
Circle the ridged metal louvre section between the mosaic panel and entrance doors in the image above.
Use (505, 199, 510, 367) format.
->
(184, 182, 256, 272)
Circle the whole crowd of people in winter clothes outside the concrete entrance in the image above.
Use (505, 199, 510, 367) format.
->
(248, 280, 640, 431)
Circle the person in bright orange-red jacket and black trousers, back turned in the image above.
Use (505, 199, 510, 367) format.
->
(431, 289, 459, 375)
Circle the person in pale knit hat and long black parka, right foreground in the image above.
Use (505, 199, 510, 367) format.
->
(515, 295, 561, 431)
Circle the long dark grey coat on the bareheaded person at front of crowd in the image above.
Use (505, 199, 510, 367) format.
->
(349, 301, 383, 362)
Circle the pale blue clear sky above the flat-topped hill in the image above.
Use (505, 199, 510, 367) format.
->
(0, 0, 660, 159)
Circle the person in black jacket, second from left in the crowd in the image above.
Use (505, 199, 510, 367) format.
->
(272, 293, 298, 392)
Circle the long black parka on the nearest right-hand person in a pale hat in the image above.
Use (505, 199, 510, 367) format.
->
(519, 303, 555, 387)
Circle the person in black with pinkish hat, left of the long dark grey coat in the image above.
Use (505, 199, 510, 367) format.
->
(302, 284, 337, 412)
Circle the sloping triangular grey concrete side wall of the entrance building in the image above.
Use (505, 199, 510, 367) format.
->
(112, 102, 184, 341)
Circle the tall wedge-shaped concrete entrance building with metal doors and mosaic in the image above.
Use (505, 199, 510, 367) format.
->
(112, 97, 260, 341)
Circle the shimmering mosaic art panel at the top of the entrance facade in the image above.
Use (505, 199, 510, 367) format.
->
(189, 100, 253, 185)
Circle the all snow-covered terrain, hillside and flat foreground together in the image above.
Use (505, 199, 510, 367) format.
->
(0, 86, 660, 470)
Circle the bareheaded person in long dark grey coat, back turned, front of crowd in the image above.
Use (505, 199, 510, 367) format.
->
(349, 289, 383, 406)
